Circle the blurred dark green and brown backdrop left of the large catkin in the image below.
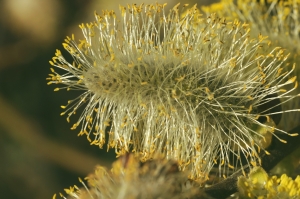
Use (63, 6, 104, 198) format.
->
(0, 0, 216, 199)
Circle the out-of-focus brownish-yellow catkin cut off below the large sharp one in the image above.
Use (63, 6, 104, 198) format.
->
(53, 154, 204, 199)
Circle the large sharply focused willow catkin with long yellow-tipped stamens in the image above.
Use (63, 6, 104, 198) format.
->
(47, 4, 297, 181)
